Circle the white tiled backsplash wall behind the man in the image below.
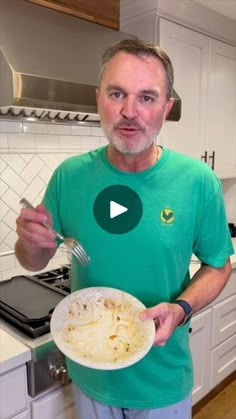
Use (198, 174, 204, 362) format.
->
(0, 120, 236, 280)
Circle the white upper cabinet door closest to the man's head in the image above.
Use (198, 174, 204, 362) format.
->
(160, 19, 209, 159)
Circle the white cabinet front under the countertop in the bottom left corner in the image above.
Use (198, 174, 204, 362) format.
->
(0, 365, 29, 419)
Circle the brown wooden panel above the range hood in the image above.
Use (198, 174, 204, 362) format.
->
(26, 0, 120, 30)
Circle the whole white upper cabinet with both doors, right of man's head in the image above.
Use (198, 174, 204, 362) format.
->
(159, 18, 236, 177)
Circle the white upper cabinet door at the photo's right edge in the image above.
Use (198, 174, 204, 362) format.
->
(207, 39, 236, 171)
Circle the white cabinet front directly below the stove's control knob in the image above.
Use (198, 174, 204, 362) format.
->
(30, 384, 76, 419)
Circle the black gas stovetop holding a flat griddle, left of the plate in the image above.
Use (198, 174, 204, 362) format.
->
(0, 265, 70, 339)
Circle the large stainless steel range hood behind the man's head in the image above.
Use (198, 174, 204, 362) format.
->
(0, 0, 181, 125)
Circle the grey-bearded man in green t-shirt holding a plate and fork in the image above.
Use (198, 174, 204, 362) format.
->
(16, 40, 233, 419)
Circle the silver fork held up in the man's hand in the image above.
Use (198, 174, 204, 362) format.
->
(20, 198, 90, 266)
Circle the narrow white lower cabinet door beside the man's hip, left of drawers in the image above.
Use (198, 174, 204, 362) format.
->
(190, 310, 211, 404)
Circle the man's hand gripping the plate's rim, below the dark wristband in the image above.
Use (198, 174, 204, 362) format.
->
(140, 303, 184, 346)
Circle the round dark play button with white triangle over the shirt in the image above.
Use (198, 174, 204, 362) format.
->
(93, 185, 143, 234)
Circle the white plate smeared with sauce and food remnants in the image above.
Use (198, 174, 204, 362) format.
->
(51, 287, 155, 370)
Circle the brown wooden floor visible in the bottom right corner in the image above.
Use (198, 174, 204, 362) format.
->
(193, 379, 236, 419)
